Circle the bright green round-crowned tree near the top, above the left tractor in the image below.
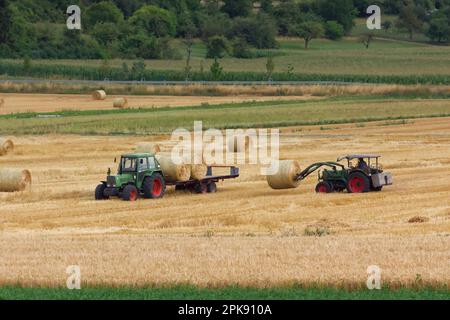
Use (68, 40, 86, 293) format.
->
(129, 5, 177, 37)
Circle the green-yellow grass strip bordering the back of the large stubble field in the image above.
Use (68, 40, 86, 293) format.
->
(0, 97, 450, 135)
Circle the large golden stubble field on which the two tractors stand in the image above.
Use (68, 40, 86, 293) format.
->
(0, 118, 450, 287)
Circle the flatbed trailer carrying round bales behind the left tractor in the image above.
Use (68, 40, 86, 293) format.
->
(166, 165, 239, 193)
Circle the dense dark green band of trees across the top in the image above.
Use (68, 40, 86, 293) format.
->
(0, 0, 450, 59)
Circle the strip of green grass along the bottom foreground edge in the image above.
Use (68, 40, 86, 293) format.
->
(0, 286, 450, 300)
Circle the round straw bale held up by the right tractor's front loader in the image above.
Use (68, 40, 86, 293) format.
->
(266, 160, 300, 189)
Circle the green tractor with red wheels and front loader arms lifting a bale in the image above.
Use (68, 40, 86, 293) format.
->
(297, 155, 392, 193)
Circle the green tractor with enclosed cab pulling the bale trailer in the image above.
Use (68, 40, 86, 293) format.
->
(95, 153, 166, 201)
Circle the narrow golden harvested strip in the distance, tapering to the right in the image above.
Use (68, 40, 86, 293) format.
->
(0, 93, 310, 114)
